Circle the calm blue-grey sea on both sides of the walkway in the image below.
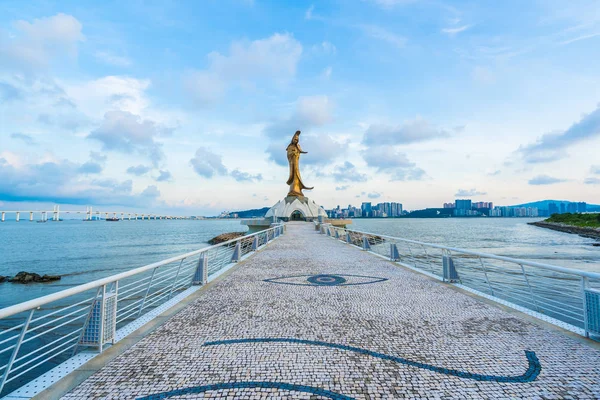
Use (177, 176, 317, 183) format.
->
(0, 218, 600, 308)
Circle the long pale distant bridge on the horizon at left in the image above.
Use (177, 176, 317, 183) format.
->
(0, 205, 192, 222)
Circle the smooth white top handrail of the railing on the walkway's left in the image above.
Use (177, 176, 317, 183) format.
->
(0, 228, 276, 319)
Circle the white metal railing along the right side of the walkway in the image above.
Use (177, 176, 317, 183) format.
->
(320, 224, 600, 337)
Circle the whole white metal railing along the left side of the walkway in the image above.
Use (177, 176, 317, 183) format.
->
(0, 224, 284, 396)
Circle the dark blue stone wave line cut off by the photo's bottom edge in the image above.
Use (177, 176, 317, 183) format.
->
(137, 382, 354, 400)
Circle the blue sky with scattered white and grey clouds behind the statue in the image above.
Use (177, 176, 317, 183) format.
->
(0, 0, 600, 215)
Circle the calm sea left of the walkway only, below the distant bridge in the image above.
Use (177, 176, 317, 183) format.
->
(0, 220, 247, 308)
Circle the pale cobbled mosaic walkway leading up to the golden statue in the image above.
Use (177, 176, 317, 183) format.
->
(64, 223, 600, 399)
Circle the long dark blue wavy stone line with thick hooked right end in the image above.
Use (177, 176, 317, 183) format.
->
(204, 338, 542, 383)
